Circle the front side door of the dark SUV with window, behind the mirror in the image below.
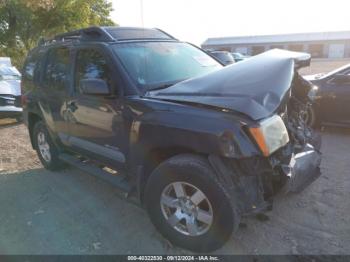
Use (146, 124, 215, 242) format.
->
(67, 48, 127, 167)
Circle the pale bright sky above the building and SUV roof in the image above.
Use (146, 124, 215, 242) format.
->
(111, 0, 350, 45)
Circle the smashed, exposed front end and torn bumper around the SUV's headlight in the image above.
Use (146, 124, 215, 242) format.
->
(212, 71, 321, 215)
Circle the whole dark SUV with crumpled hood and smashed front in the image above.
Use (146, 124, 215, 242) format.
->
(23, 27, 321, 251)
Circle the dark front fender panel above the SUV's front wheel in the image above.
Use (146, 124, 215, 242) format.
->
(127, 98, 260, 161)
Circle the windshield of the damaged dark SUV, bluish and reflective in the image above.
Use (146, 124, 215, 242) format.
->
(113, 42, 222, 90)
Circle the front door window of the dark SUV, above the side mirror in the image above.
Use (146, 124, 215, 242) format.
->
(75, 49, 112, 92)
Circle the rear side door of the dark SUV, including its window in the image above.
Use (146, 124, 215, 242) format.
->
(39, 47, 72, 138)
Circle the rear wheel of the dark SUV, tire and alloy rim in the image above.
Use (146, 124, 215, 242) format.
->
(33, 121, 65, 170)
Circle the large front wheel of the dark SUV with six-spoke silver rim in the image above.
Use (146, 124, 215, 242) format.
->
(145, 155, 239, 252)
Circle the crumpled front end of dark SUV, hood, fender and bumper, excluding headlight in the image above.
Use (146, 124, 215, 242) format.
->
(130, 51, 321, 215)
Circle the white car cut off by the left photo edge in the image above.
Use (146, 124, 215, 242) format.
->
(0, 57, 22, 121)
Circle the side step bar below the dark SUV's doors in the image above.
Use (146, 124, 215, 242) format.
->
(59, 153, 132, 194)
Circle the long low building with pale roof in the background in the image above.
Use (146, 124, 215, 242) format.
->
(202, 31, 350, 58)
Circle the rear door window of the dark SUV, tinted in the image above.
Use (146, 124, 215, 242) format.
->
(45, 48, 70, 90)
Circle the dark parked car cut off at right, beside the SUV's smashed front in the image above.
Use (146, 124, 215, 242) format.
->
(306, 64, 350, 126)
